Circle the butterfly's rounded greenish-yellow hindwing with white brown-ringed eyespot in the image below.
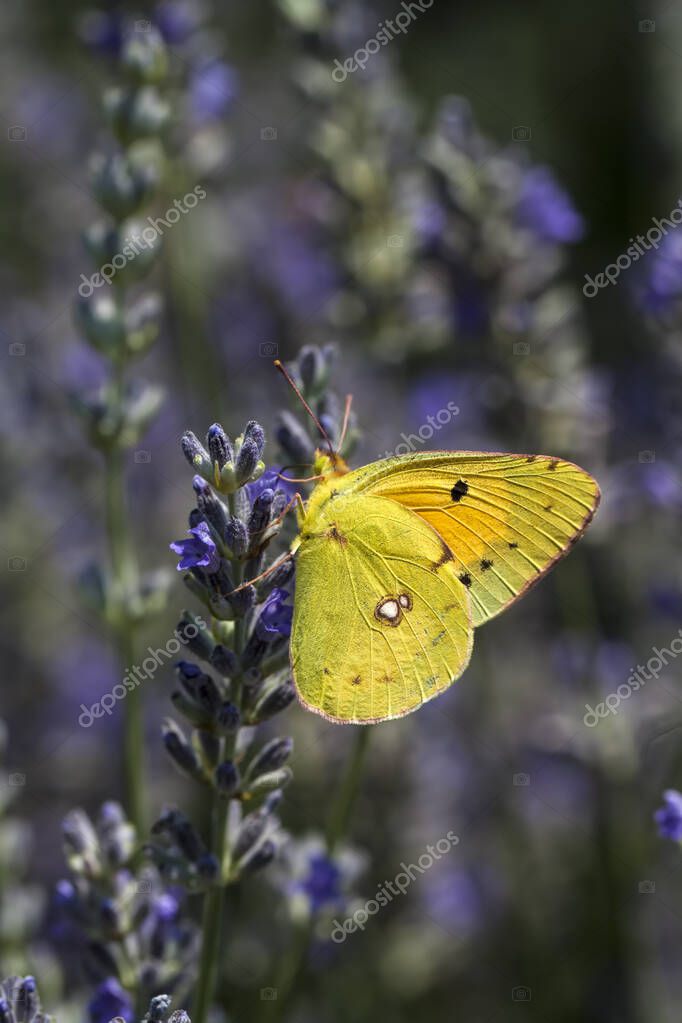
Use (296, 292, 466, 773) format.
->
(291, 493, 472, 723)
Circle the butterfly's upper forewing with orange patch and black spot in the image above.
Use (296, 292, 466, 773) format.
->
(333, 451, 599, 626)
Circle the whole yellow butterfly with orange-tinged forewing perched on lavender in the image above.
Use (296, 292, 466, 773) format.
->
(290, 451, 600, 724)
